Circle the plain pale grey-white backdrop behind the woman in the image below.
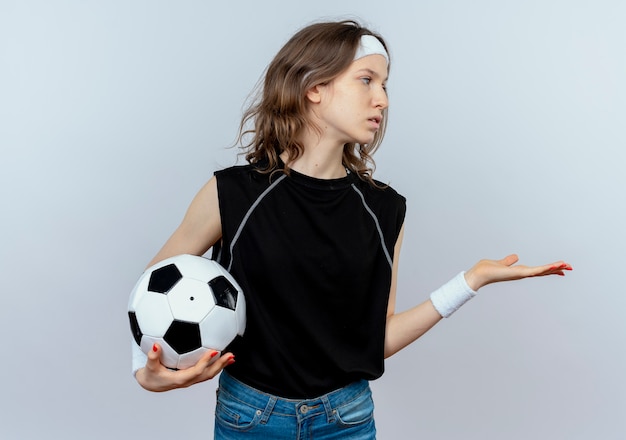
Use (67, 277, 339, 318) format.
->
(0, 0, 626, 440)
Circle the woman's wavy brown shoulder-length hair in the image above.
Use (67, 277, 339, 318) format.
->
(238, 20, 387, 184)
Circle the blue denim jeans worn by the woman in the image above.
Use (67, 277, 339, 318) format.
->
(215, 371, 376, 440)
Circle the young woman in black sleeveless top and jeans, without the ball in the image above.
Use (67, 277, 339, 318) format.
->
(133, 21, 571, 439)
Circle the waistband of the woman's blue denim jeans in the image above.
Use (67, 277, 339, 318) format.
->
(219, 371, 369, 417)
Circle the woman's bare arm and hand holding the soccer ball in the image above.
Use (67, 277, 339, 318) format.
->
(133, 177, 235, 391)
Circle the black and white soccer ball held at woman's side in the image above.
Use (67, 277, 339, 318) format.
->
(128, 254, 246, 369)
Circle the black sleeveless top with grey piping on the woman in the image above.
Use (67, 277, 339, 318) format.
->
(213, 165, 406, 399)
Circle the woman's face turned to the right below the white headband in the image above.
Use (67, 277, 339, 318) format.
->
(307, 55, 389, 146)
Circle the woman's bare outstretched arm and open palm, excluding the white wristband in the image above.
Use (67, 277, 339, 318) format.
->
(385, 226, 572, 357)
